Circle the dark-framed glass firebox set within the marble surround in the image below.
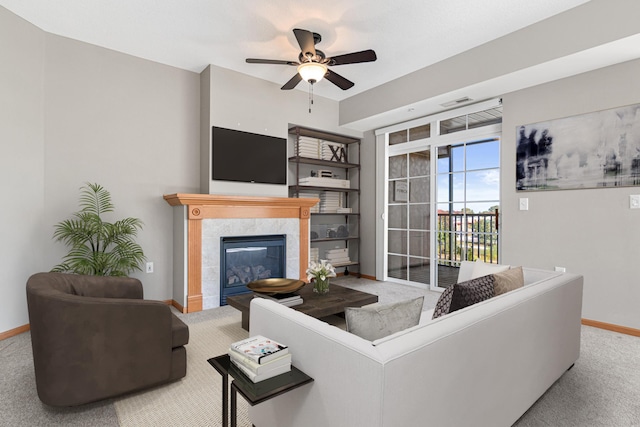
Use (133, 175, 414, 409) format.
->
(220, 234, 287, 306)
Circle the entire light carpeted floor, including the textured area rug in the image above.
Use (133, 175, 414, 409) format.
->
(0, 276, 640, 427)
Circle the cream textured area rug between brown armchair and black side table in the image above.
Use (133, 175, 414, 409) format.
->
(114, 312, 251, 427)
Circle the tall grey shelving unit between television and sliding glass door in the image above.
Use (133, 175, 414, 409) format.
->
(289, 127, 360, 275)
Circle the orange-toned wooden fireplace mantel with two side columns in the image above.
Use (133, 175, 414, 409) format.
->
(164, 193, 319, 313)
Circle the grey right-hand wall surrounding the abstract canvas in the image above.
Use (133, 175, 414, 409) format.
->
(502, 60, 640, 329)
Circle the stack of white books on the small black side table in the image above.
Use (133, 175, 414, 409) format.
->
(229, 335, 291, 383)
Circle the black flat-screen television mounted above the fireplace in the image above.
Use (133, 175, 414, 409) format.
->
(211, 126, 287, 184)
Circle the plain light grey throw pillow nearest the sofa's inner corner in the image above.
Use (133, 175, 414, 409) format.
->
(344, 297, 424, 341)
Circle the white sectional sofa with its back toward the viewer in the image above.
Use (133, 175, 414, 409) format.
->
(250, 268, 582, 427)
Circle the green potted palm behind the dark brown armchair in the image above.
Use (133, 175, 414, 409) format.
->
(51, 183, 145, 276)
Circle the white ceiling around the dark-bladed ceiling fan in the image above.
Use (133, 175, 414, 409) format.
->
(0, 0, 587, 100)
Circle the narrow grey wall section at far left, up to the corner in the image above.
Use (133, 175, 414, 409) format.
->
(0, 7, 45, 333)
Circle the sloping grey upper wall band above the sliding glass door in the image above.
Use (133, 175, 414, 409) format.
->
(340, 0, 640, 126)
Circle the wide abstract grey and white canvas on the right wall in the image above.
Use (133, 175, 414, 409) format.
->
(516, 104, 640, 191)
